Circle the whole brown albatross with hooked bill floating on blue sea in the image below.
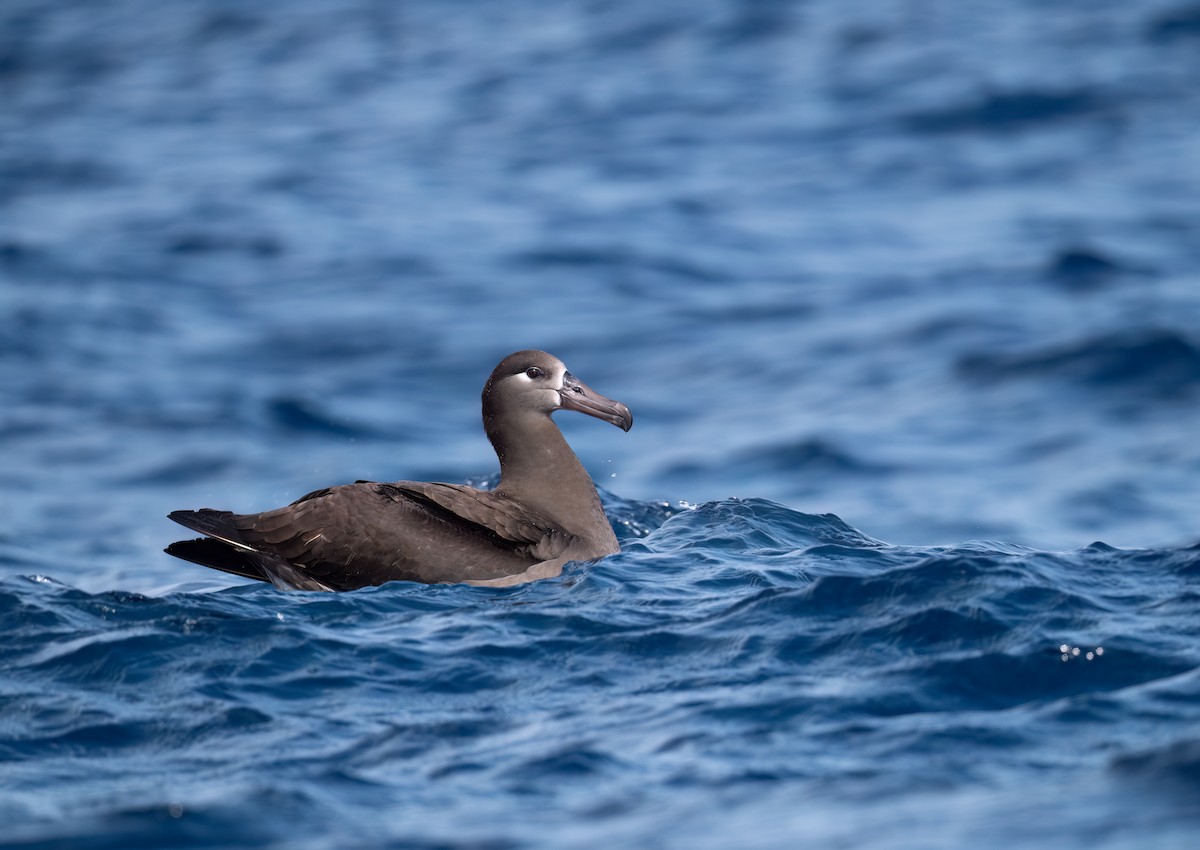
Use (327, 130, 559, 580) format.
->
(166, 351, 634, 591)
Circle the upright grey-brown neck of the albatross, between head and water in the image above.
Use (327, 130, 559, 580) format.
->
(485, 413, 618, 556)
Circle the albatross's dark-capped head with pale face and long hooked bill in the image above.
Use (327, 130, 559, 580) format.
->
(484, 349, 634, 431)
